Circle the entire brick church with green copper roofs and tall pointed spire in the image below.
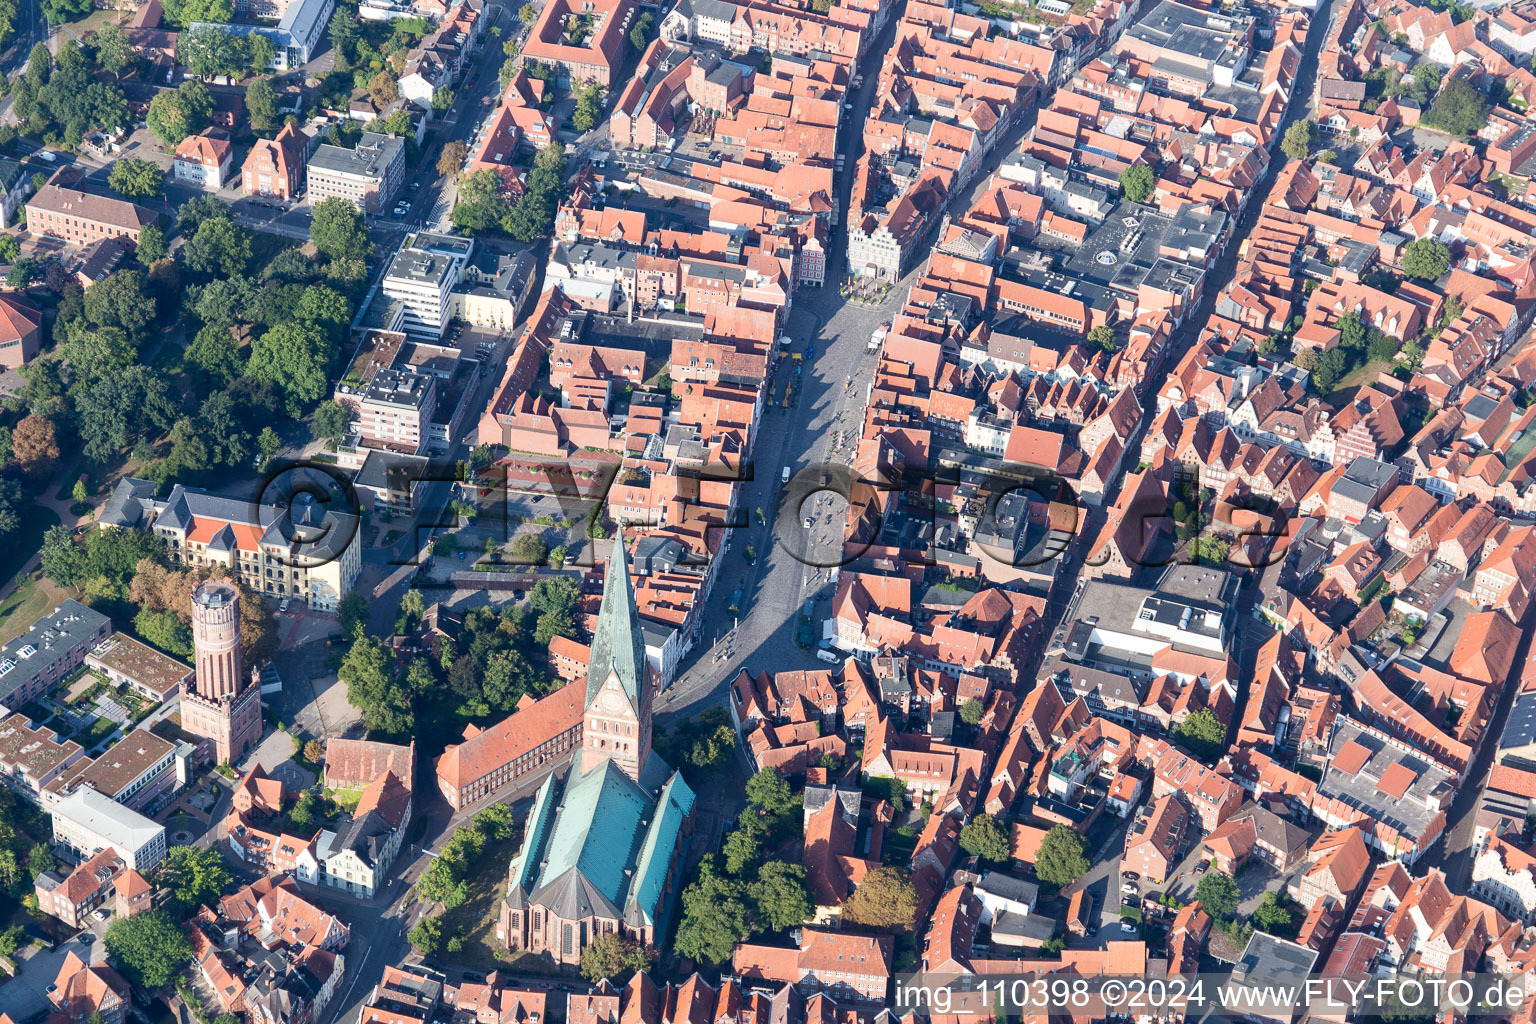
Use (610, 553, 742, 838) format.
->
(496, 534, 694, 964)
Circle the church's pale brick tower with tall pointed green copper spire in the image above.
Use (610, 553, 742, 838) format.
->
(581, 531, 651, 781)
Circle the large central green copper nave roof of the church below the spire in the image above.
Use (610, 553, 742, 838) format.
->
(533, 758, 653, 920)
